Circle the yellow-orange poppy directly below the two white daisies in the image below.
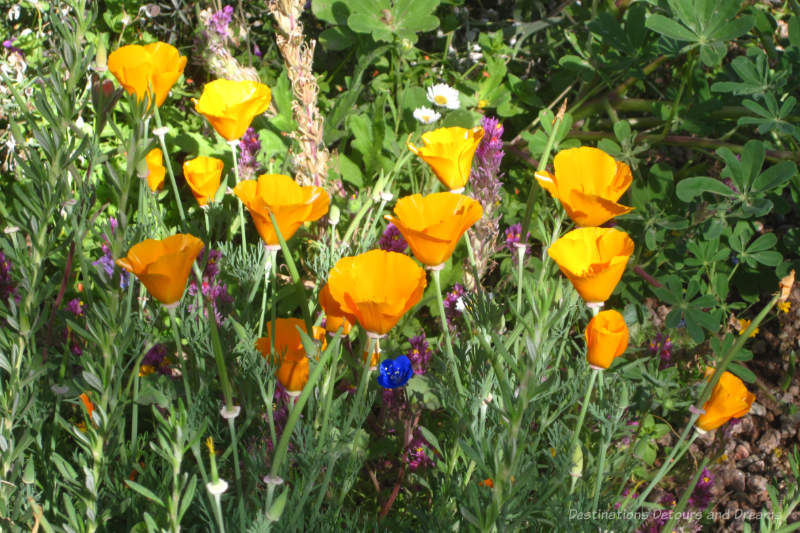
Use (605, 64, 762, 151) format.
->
(408, 126, 483, 192)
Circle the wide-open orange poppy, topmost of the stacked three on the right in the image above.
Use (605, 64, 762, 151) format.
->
(535, 146, 633, 227)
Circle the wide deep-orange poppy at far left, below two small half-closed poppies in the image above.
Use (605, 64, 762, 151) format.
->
(117, 233, 204, 306)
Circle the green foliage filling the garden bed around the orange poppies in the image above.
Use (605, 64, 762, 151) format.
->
(0, 0, 800, 532)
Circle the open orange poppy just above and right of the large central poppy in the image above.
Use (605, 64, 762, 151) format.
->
(385, 192, 483, 267)
